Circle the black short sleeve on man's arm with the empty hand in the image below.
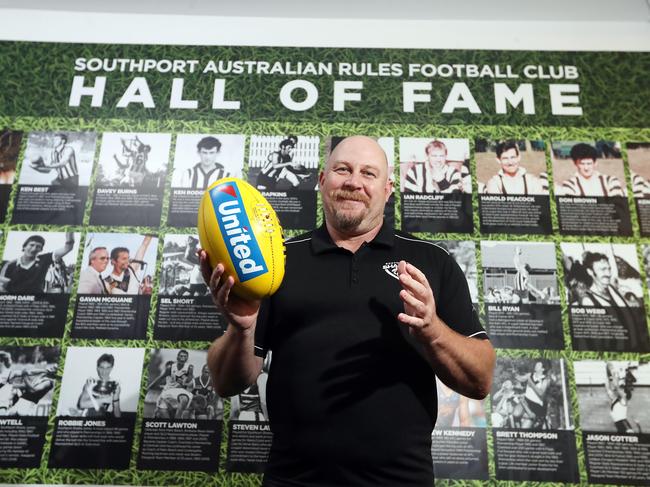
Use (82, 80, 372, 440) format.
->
(436, 256, 488, 339)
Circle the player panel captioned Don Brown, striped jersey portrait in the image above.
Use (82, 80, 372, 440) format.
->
(551, 140, 632, 235)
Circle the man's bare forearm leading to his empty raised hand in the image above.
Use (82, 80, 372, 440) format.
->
(425, 324, 496, 399)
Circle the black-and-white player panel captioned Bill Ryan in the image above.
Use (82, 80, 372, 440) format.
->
(481, 241, 564, 350)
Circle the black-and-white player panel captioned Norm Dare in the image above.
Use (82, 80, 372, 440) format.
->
(0, 230, 79, 338)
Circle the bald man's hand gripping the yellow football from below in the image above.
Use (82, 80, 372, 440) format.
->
(199, 250, 260, 331)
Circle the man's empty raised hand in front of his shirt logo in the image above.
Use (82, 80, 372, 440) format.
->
(397, 260, 444, 343)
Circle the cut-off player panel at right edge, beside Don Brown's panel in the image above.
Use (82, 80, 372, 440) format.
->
(626, 142, 650, 237)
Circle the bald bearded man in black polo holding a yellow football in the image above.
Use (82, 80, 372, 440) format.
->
(200, 136, 494, 487)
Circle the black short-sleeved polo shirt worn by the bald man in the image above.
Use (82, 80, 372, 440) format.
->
(255, 225, 486, 487)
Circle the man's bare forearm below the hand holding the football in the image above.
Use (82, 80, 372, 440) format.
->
(208, 325, 262, 397)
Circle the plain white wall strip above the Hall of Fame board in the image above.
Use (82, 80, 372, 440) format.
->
(0, 4, 650, 51)
